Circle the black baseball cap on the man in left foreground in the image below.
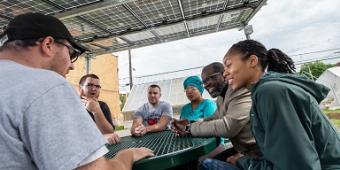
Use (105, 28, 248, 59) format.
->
(0, 13, 88, 54)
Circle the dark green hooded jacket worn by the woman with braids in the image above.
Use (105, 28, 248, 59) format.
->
(237, 72, 340, 170)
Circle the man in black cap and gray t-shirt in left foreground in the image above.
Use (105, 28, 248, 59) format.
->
(0, 13, 153, 170)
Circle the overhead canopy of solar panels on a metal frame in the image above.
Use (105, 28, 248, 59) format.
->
(0, 0, 266, 54)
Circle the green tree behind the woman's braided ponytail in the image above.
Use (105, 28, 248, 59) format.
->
(299, 61, 336, 80)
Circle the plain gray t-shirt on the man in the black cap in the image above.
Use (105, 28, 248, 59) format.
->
(0, 60, 106, 170)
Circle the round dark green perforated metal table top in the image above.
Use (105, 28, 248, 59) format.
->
(105, 131, 217, 170)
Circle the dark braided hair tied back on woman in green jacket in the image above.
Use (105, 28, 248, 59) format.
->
(227, 40, 295, 73)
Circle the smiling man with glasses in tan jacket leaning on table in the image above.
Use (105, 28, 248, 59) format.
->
(173, 62, 259, 166)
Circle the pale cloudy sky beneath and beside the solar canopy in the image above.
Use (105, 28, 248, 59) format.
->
(113, 0, 340, 90)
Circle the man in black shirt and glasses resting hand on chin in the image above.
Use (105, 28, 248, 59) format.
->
(79, 74, 115, 134)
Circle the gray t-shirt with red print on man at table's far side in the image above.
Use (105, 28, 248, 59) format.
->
(134, 101, 173, 129)
